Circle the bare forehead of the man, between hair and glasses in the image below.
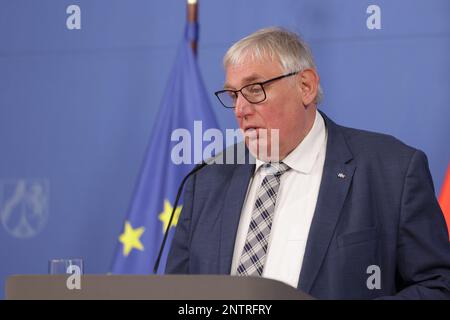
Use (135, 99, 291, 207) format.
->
(224, 54, 282, 88)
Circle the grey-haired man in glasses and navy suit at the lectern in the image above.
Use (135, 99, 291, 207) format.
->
(166, 28, 450, 299)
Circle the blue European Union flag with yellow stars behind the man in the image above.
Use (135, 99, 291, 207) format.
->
(112, 23, 218, 274)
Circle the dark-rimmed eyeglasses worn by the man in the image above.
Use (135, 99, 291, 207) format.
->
(214, 71, 300, 109)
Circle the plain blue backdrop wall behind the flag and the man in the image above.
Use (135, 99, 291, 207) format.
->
(0, 0, 450, 297)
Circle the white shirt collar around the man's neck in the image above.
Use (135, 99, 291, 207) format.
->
(255, 111, 326, 174)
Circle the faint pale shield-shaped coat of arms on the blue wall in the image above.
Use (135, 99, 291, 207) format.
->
(0, 179, 49, 239)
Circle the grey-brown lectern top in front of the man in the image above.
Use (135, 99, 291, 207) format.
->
(5, 275, 313, 300)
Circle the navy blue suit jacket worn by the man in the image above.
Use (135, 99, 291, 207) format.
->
(166, 113, 450, 299)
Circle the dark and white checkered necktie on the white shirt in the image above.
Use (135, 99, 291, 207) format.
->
(237, 162, 290, 276)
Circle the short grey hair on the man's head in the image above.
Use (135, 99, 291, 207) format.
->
(223, 27, 323, 104)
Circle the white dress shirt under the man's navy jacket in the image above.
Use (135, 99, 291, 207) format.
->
(231, 111, 327, 288)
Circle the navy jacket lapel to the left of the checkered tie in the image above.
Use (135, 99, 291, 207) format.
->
(219, 164, 255, 274)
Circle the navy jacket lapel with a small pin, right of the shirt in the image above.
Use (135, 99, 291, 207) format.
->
(298, 113, 355, 292)
